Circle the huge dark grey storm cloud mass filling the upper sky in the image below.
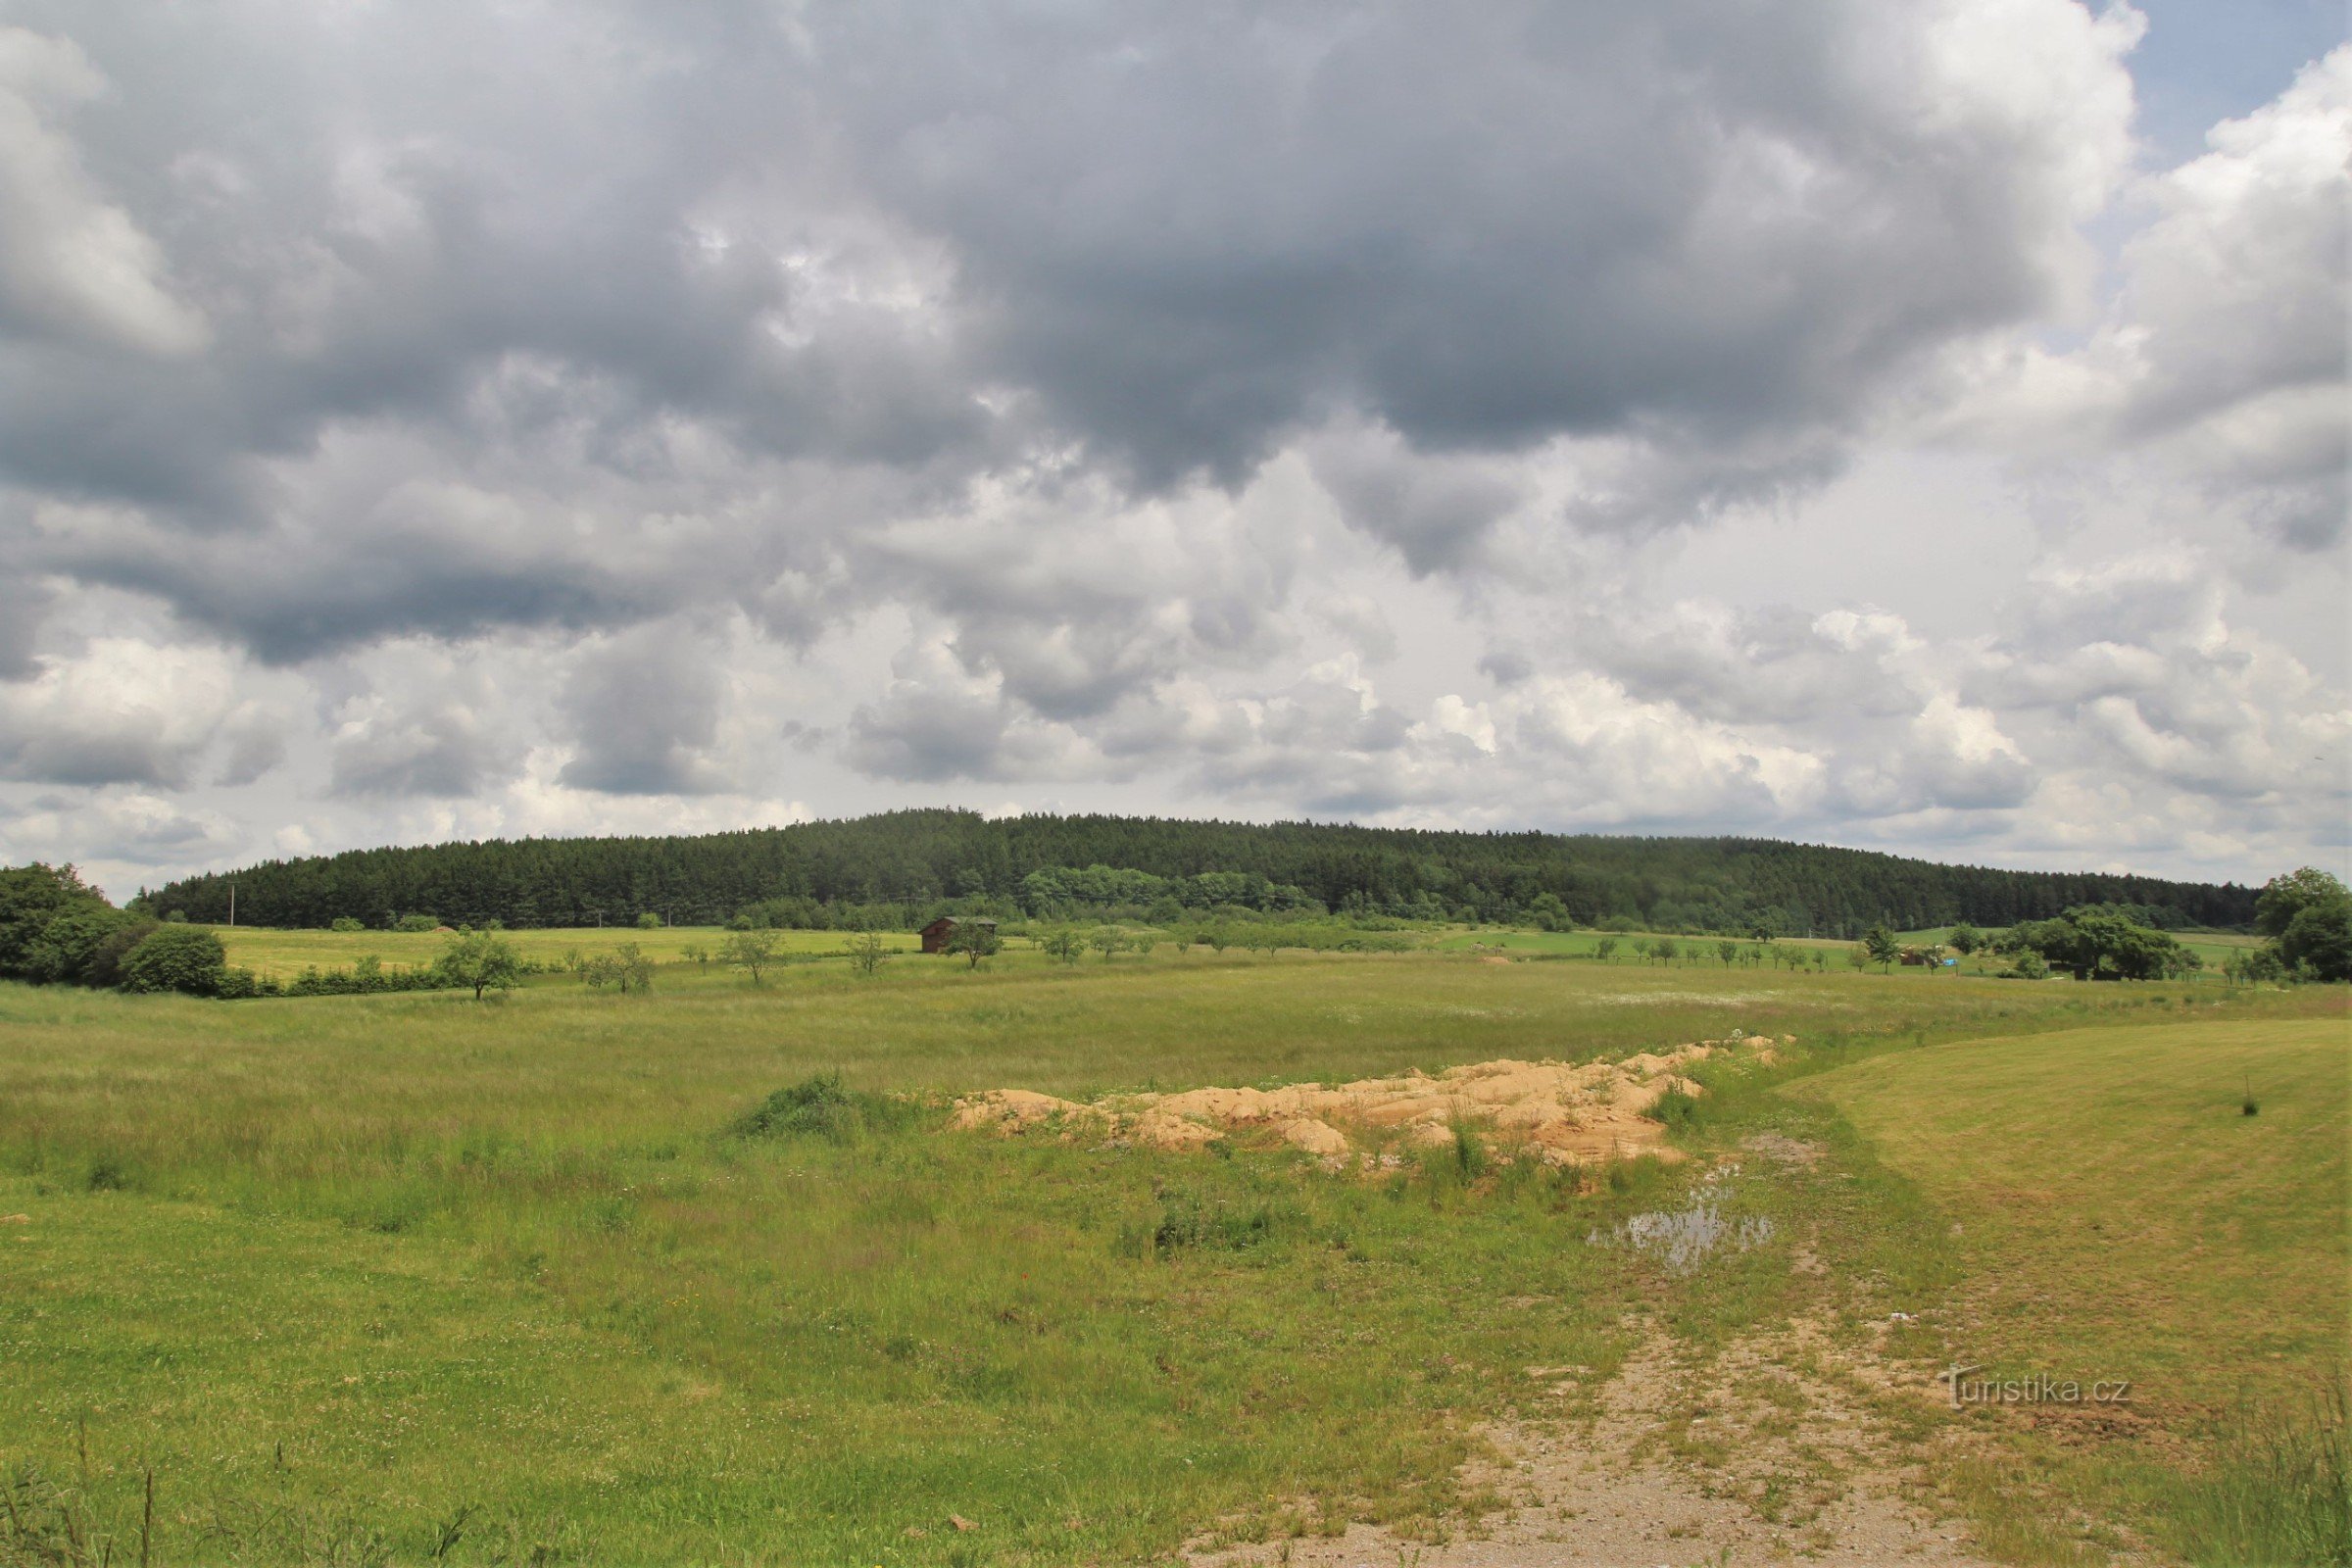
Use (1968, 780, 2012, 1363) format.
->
(0, 0, 2154, 659)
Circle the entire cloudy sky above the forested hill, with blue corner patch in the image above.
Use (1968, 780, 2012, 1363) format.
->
(0, 0, 2352, 898)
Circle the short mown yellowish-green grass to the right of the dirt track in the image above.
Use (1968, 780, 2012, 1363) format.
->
(1792, 1018, 2352, 1561)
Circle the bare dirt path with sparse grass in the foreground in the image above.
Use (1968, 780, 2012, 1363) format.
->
(1195, 1324, 1987, 1568)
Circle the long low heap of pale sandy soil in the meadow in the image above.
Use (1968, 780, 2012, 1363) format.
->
(955, 1034, 1794, 1166)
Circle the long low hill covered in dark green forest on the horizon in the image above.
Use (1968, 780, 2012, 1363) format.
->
(141, 811, 2253, 936)
